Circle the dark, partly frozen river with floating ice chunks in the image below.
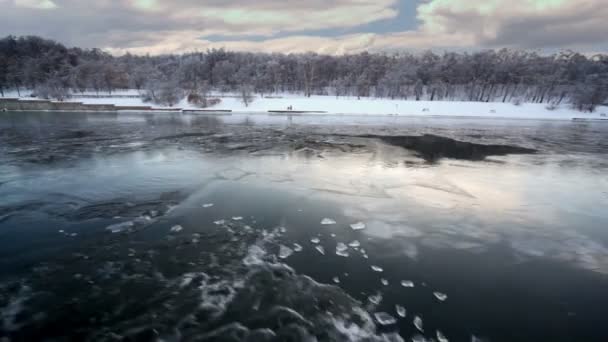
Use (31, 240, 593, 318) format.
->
(0, 113, 608, 341)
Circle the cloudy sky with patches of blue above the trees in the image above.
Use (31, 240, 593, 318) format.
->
(0, 0, 608, 54)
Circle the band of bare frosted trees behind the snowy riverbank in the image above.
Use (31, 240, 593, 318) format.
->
(0, 36, 608, 111)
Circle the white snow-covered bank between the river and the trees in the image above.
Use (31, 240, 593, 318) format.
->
(5, 90, 608, 120)
